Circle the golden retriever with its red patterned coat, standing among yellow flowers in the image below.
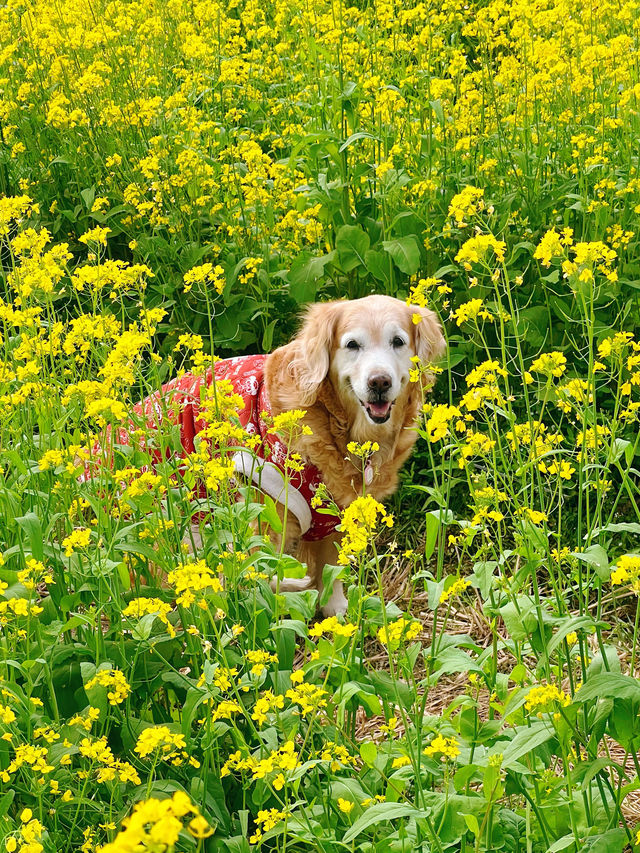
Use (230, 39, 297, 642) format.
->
(105, 295, 445, 616)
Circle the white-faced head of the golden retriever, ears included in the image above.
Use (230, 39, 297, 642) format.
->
(291, 296, 445, 426)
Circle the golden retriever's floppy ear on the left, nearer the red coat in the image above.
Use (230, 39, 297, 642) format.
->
(290, 302, 341, 406)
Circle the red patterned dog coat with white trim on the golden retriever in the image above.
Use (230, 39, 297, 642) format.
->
(130, 355, 339, 541)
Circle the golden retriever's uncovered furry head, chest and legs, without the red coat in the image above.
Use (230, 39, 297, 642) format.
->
(264, 295, 445, 615)
